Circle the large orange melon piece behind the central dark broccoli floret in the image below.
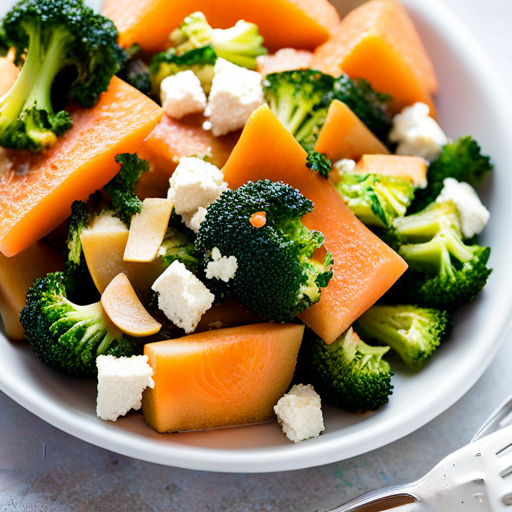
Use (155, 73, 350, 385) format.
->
(224, 106, 407, 343)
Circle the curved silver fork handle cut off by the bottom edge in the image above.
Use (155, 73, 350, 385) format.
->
(325, 485, 420, 512)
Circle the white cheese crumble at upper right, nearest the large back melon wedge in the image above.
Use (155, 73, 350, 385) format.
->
(389, 102, 448, 161)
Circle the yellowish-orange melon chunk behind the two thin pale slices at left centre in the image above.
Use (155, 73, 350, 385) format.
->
(80, 214, 165, 304)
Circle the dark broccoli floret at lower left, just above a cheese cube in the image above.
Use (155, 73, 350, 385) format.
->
(20, 272, 139, 377)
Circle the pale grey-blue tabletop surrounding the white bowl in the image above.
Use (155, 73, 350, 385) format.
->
(0, 0, 512, 512)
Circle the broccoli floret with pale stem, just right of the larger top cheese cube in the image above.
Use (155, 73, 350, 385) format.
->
(263, 69, 334, 151)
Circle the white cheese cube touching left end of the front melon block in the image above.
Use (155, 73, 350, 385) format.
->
(96, 356, 155, 421)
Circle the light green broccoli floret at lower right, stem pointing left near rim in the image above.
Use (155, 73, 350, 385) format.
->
(354, 305, 453, 370)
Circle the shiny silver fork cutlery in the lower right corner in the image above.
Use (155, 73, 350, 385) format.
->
(320, 397, 512, 512)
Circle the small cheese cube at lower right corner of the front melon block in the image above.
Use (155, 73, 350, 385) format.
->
(274, 384, 325, 443)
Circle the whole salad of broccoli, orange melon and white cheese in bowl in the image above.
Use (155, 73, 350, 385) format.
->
(0, 0, 492, 441)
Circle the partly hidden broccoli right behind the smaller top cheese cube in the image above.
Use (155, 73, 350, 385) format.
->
(149, 45, 217, 98)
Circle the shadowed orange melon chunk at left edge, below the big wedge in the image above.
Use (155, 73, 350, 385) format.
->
(0, 242, 64, 340)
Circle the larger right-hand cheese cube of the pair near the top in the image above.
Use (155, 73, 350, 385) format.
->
(207, 59, 265, 137)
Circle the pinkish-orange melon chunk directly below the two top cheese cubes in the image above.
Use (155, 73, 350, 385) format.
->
(137, 114, 240, 198)
